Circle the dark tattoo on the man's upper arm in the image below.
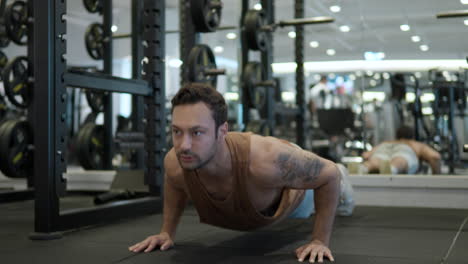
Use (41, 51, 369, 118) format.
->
(276, 152, 324, 184)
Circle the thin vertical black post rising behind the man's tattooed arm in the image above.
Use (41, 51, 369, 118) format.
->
(292, 0, 307, 148)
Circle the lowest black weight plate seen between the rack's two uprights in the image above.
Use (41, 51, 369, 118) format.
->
(77, 123, 104, 170)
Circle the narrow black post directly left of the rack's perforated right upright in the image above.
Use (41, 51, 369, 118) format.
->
(131, 0, 144, 169)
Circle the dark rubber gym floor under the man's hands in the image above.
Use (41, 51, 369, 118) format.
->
(0, 196, 468, 264)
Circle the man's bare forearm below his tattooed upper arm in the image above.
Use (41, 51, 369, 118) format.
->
(312, 168, 341, 246)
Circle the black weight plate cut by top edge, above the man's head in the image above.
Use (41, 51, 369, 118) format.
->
(190, 0, 223, 32)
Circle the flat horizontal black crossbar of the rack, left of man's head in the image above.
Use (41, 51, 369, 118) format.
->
(63, 71, 152, 95)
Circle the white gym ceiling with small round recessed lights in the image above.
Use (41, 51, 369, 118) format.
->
(6, 0, 468, 66)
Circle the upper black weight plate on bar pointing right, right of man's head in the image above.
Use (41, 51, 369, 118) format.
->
(243, 10, 269, 51)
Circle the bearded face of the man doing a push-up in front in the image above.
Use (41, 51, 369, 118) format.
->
(172, 102, 217, 170)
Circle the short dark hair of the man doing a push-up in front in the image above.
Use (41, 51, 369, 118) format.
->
(171, 83, 227, 136)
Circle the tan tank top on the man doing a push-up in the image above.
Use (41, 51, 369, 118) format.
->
(184, 132, 304, 231)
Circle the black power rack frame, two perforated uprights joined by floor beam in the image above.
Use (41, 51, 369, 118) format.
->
(31, 0, 165, 239)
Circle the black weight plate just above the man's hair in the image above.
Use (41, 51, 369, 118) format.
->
(186, 44, 218, 88)
